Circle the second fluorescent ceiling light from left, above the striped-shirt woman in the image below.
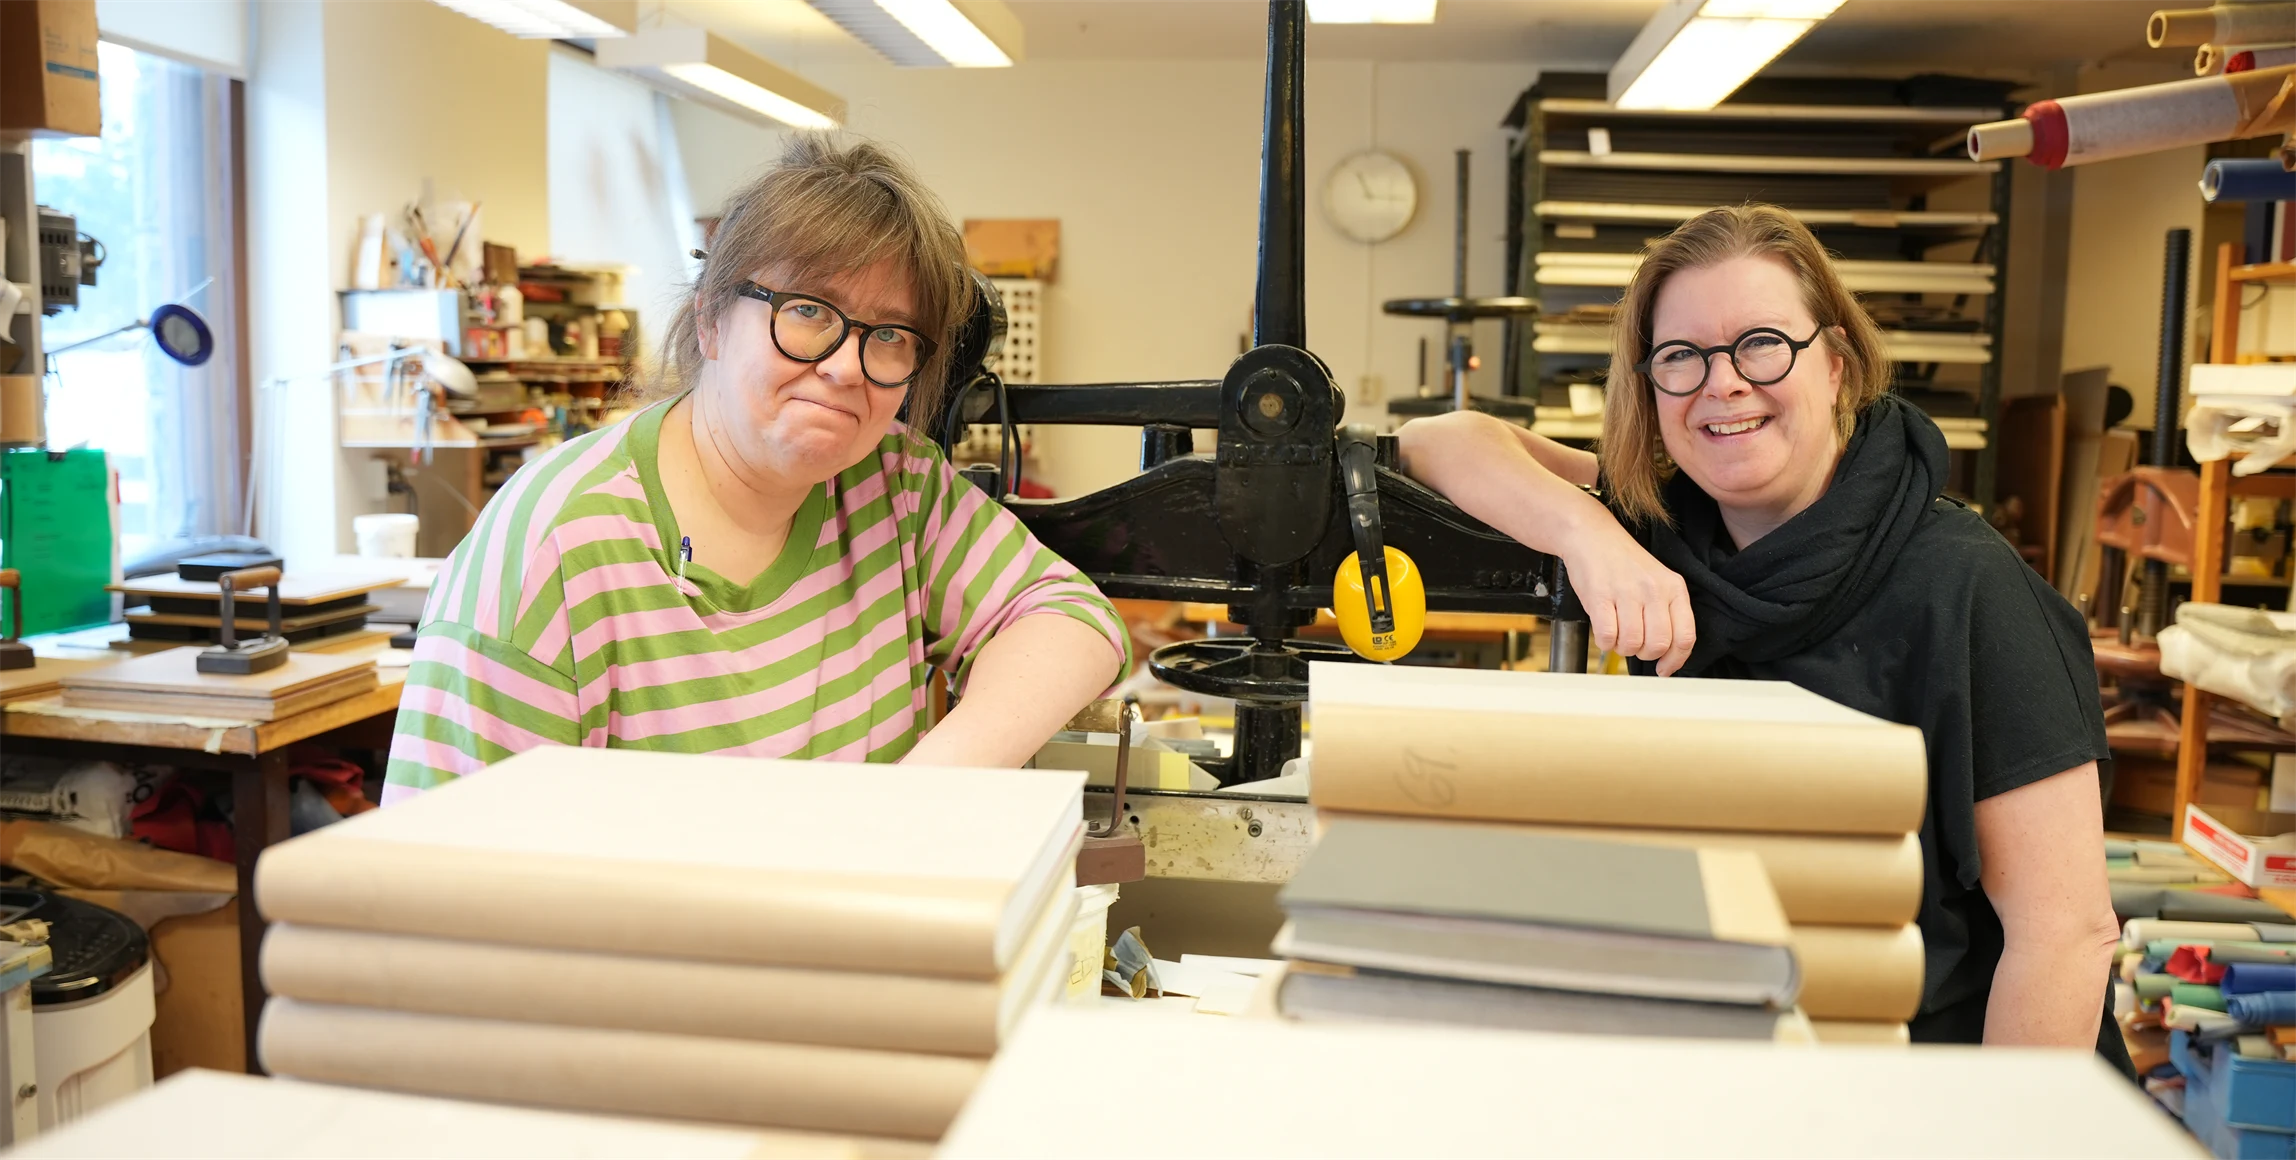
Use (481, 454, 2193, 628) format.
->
(597, 28, 845, 129)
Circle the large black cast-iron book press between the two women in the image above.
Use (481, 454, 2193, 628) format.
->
(941, 0, 1587, 786)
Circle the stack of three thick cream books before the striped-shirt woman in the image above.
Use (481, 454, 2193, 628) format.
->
(255, 749, 1084, 1142)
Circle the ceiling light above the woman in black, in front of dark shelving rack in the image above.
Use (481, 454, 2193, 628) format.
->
(1609, 0, 1844, 110)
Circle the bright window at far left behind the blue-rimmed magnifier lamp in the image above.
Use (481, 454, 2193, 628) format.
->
(32, 44, 241, 560)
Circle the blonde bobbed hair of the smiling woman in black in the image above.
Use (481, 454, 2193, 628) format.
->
(1600, 204, 1892, 524)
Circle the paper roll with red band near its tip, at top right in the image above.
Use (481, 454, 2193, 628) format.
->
(1970, 64, 2296, 170)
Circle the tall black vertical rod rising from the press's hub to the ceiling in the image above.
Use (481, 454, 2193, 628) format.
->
(1251, 0, 1306, 349)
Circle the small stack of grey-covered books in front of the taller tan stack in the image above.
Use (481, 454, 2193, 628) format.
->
(1274, 818, 1798, 1038)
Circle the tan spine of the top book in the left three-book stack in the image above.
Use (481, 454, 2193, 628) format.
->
(255, 832, 1006, 979)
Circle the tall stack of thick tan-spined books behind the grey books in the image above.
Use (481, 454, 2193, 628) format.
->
(1309, 664, 1929, 1043)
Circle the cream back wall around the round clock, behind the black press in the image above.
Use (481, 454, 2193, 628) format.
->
(675, 60, 1536, 494)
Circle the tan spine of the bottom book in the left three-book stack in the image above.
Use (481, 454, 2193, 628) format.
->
(257, 997, 987, 1139)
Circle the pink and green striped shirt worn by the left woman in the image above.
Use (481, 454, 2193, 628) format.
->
(383, 404, 1127, 802)
